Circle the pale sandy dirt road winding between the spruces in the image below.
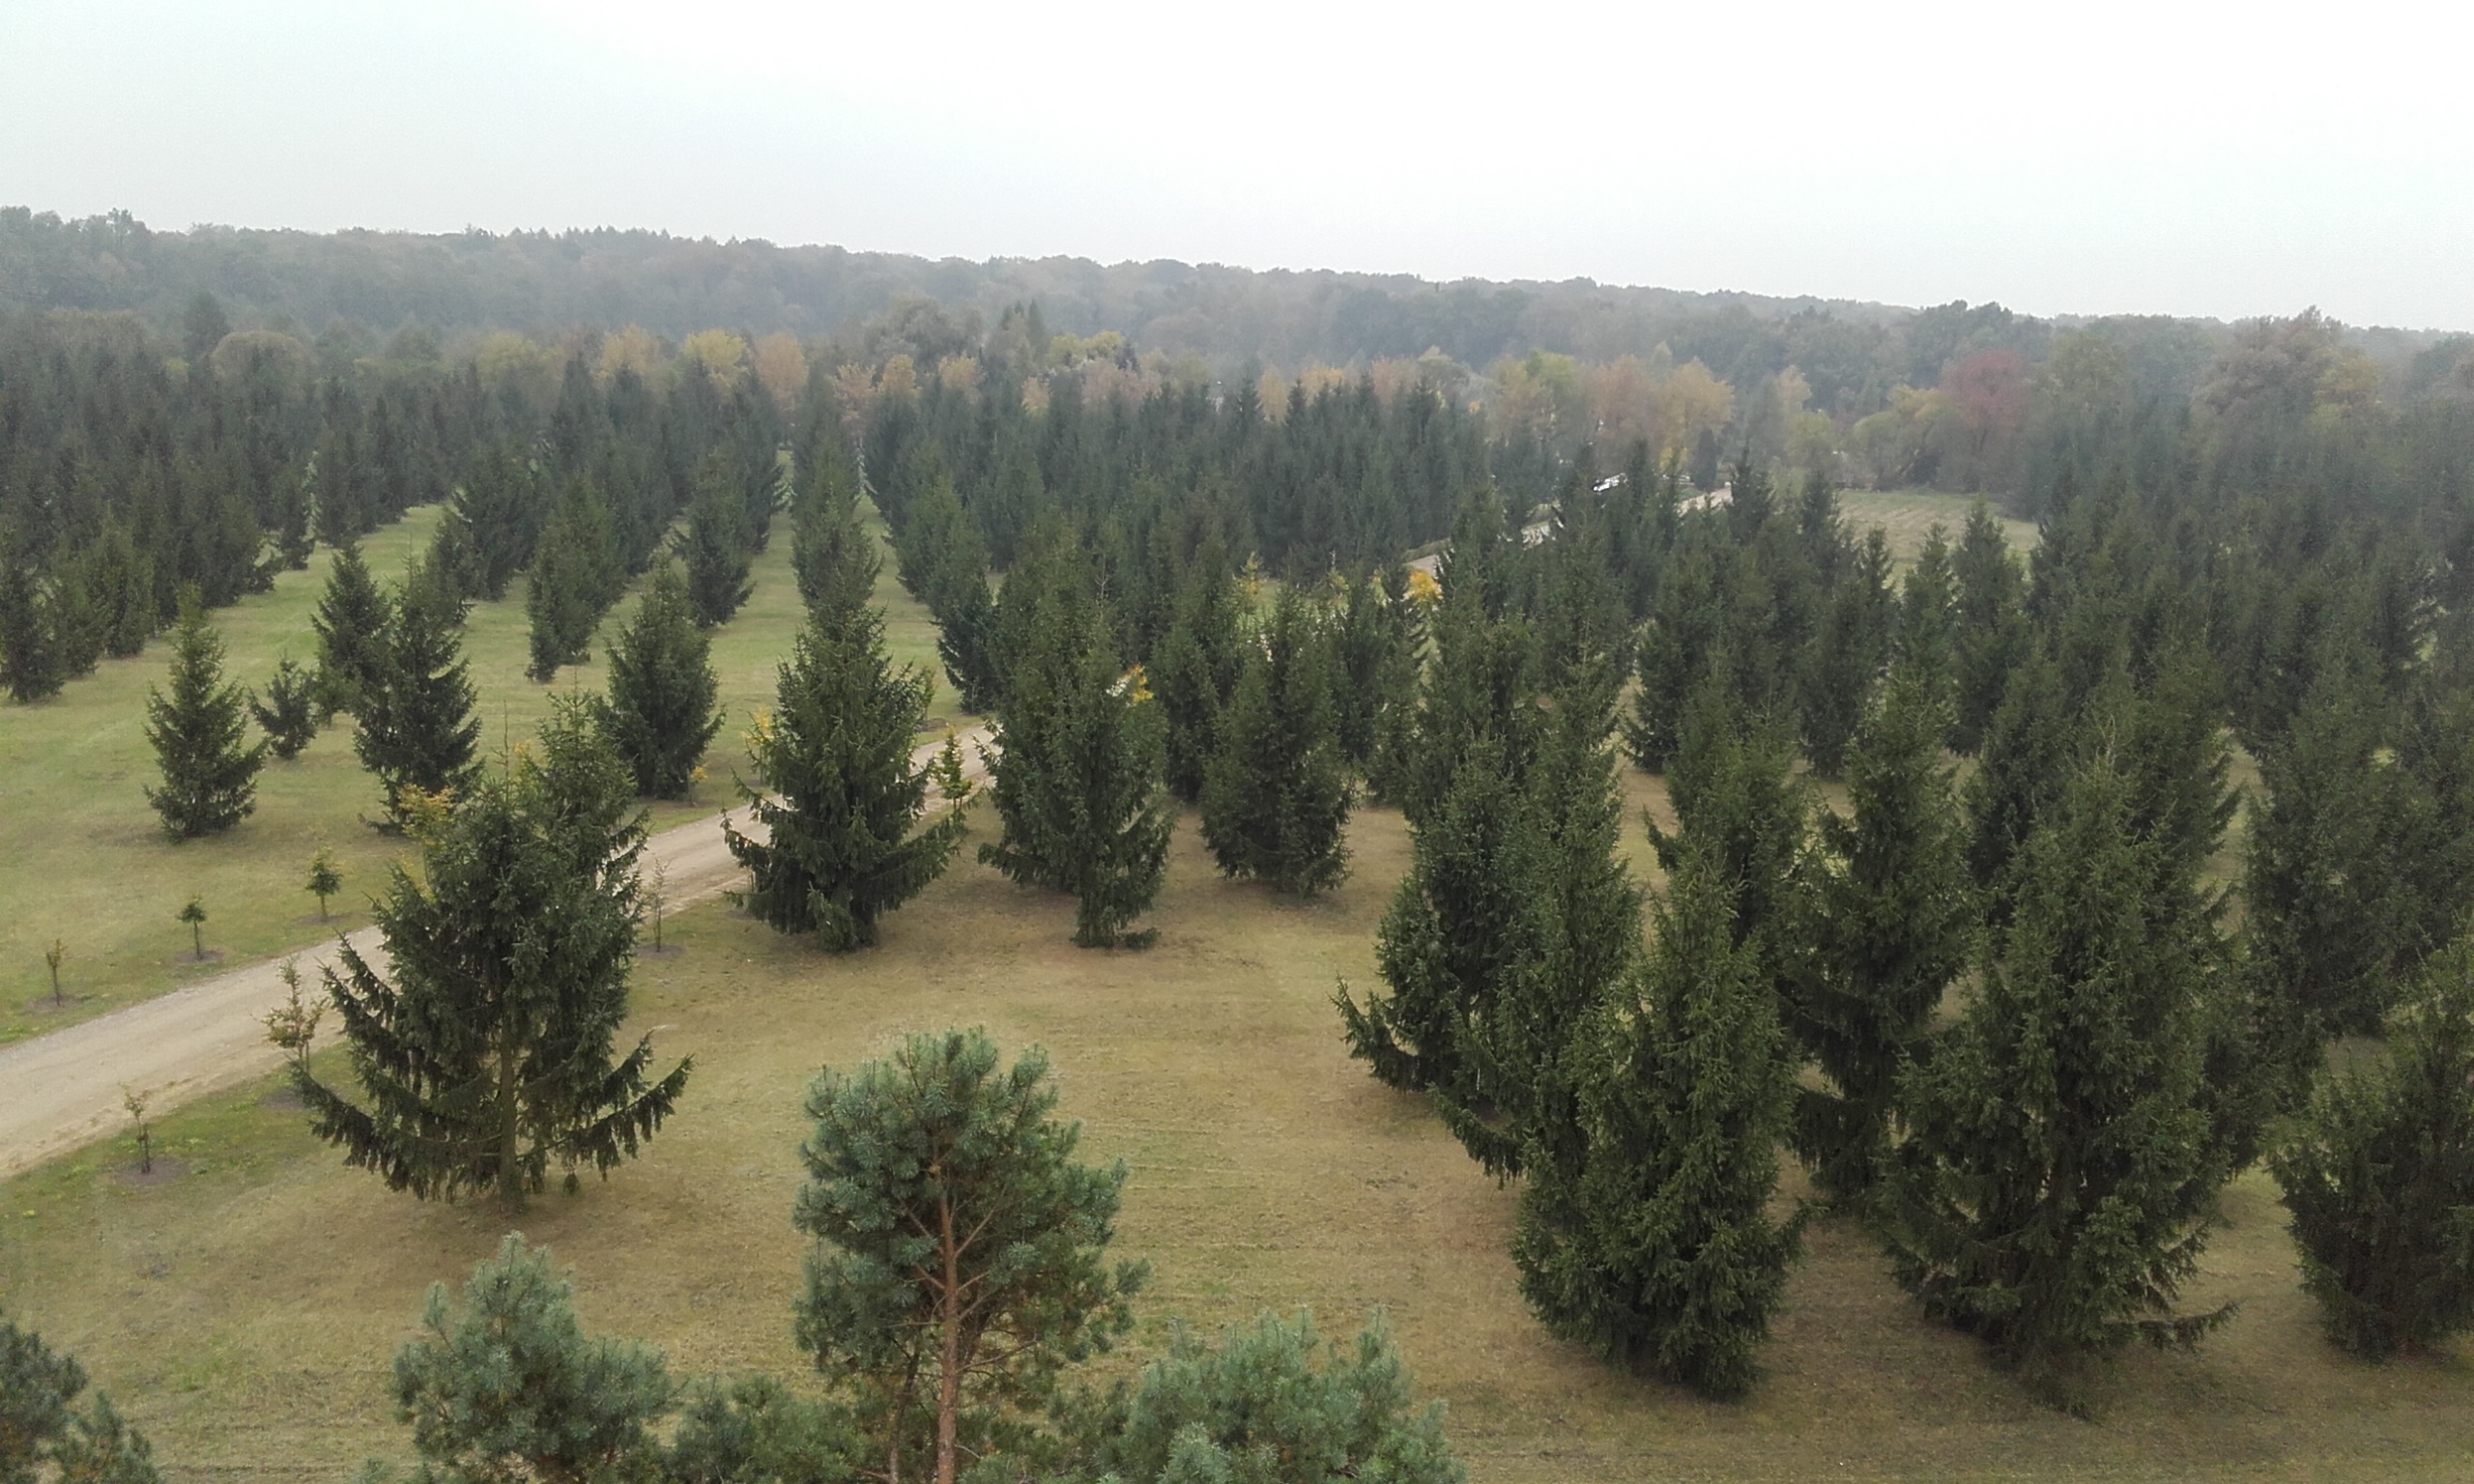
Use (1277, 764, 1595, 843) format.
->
(0, 728, 987, 1178)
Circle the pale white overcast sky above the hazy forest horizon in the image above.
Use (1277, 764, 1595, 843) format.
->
(0, 0, 2474, 328)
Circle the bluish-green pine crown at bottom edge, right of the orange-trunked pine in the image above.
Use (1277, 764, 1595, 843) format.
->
(1094, 1313, 1470, 1484)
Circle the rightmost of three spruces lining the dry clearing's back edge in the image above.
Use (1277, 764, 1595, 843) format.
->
(1202, 586, 1356, 896)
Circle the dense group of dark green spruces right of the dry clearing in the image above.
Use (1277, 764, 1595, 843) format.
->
(1341, 465, 2474, 1405)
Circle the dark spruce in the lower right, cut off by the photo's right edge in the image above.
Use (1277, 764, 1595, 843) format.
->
(2269, 934, 2474, 1357)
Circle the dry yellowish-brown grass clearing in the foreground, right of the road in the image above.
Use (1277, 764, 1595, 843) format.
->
(0, 774, 2474, 1481)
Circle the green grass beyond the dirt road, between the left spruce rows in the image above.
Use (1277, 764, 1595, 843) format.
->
(0, 507, 935, 1042)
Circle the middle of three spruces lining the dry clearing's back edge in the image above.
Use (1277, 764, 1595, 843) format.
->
(980, 601, 1178, 947)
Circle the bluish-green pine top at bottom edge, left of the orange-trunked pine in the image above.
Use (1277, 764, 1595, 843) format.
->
(393, 1232, 673, 1481)
